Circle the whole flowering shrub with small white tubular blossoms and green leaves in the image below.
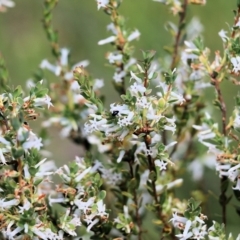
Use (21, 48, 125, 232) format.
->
(0, 0, 240, 240)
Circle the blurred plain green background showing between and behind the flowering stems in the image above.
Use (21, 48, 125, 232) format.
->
(0, 0, 240, 234)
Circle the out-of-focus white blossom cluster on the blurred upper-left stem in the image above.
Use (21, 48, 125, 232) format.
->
(40, 48, 104, 141)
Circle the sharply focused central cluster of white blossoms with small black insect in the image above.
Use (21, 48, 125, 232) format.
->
(84, 66, 181, 162)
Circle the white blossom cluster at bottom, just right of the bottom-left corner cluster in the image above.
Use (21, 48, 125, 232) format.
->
(49, 157, 108, 236)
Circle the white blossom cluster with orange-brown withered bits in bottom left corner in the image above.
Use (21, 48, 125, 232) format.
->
(0, 159, 59, 240)
